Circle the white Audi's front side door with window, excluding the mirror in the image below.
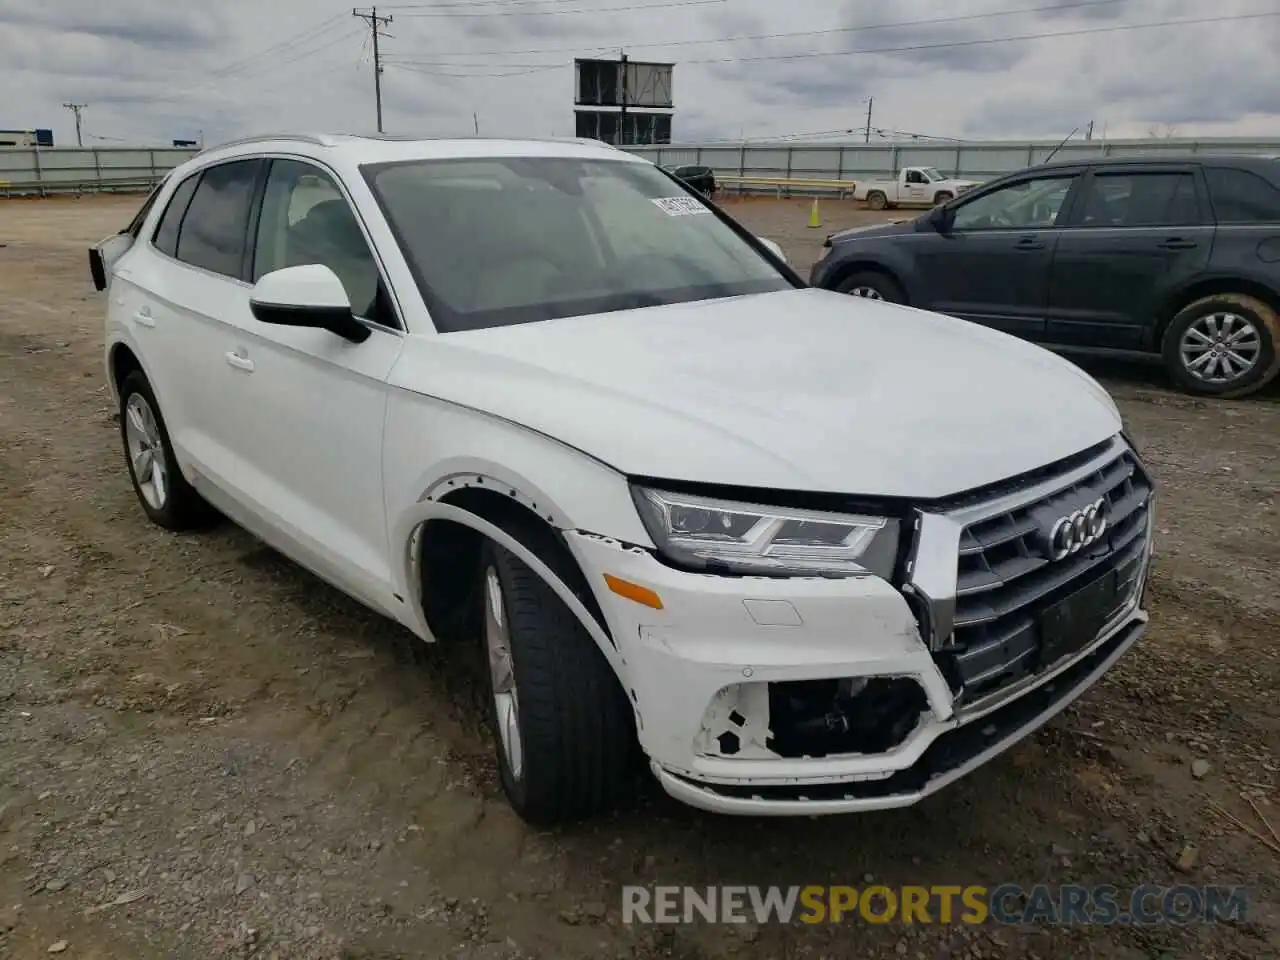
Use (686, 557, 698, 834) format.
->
(215, 159, 403, 612)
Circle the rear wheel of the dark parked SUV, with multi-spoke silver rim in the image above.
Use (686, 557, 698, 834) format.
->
(1161, 293, 1280, 399)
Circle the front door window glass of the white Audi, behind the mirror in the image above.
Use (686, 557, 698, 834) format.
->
(253, 160, 384, 326)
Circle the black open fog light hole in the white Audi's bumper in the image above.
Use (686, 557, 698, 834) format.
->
(768, 677, 928, 759)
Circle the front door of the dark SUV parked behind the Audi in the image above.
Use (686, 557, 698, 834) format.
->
(916, 170, 1079, 340)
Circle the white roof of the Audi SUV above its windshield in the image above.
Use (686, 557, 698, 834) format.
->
(193, 133, 648, 164)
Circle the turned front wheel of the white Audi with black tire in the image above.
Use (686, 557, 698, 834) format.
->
(479, 541, 636, 826)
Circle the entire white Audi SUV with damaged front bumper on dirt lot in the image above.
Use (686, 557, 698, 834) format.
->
(90, 136, 1153, 823)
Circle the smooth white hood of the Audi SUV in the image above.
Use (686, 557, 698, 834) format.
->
(393, 289, 1121, 498)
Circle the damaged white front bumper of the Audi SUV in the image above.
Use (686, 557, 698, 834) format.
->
(567, 499, 1149, 815)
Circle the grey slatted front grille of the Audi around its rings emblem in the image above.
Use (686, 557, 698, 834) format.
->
(937, 447, 1152, 703)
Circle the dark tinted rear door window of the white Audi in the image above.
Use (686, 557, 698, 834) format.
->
(178, 160, 261, 278)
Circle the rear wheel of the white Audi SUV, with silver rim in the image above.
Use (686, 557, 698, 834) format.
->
(120, 370, 216, 531)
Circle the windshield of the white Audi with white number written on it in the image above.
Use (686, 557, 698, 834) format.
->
(362, 157, 792, 333)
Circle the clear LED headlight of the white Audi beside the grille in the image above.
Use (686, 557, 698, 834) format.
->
(631, 486, 899, 580)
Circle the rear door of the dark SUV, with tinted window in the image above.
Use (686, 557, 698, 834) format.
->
(1046, 164, 1215, 349)
